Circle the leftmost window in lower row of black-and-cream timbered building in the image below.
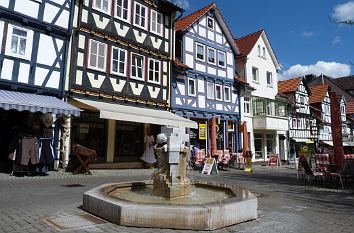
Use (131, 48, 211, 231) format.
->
(88, 40, 107, 71)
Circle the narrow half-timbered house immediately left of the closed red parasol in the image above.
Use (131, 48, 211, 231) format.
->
(309, 84, 333, 146)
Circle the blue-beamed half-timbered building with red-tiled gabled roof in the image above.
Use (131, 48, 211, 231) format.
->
(171, 3, 240, 153)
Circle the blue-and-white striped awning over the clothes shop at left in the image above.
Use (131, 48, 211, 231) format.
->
(0, 90, 81, 116)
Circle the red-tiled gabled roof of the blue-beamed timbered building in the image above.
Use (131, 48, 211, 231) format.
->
(175, 3, 240, 55)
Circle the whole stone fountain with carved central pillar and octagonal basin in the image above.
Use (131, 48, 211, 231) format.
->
(83, 127, 257, 230)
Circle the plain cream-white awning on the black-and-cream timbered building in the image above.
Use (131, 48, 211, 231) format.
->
(74, 98, 198, 129)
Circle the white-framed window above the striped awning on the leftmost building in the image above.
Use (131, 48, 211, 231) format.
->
(6, 24, 33, 59)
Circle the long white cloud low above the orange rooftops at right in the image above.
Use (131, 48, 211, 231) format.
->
(280, 61, 351, 79)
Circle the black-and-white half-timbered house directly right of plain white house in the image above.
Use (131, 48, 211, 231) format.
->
(278, 77, 320, 157)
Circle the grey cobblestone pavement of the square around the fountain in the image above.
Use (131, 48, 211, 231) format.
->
(0, 167, 354, 233)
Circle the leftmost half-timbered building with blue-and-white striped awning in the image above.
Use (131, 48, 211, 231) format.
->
(0, 0, 79, 172)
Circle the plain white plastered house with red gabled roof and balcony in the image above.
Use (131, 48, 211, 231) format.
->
(235, 30, 288, 161)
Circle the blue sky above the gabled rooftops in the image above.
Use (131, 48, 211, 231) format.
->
(176, 0, 354, 78)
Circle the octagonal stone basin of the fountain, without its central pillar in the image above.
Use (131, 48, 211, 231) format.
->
(83, 181, 257, 230)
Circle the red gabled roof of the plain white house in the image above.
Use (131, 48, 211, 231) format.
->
(234, 29, 281, 70)
